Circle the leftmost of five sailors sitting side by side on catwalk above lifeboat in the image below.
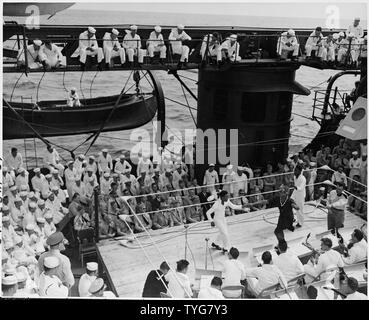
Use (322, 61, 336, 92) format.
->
(73, 27, 104, 65)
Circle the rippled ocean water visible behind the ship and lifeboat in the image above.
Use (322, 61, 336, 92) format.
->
(3, 10, 355, 167)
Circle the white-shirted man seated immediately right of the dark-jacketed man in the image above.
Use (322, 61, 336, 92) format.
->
(165, 259, 193, 299)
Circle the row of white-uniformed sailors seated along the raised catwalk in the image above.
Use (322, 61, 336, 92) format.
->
(17, 18, 367, 70)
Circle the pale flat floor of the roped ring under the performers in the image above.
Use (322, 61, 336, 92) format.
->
(97, 204, 365, 298)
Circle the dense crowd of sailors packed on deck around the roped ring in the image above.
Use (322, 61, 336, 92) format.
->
(1, 132, 367, 296)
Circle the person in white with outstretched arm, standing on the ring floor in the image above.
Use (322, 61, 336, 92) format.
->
(206, 190, 243, 252)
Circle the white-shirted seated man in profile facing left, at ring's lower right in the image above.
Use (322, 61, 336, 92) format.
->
(304, 238, 344, 283)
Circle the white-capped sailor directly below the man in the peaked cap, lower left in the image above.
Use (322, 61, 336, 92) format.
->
(39, 256, 68, 298)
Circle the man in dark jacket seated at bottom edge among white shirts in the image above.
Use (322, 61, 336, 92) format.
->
(142, 261, 169, 298)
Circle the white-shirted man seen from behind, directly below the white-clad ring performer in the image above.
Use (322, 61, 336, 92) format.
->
(222, 247, 246, 298)
